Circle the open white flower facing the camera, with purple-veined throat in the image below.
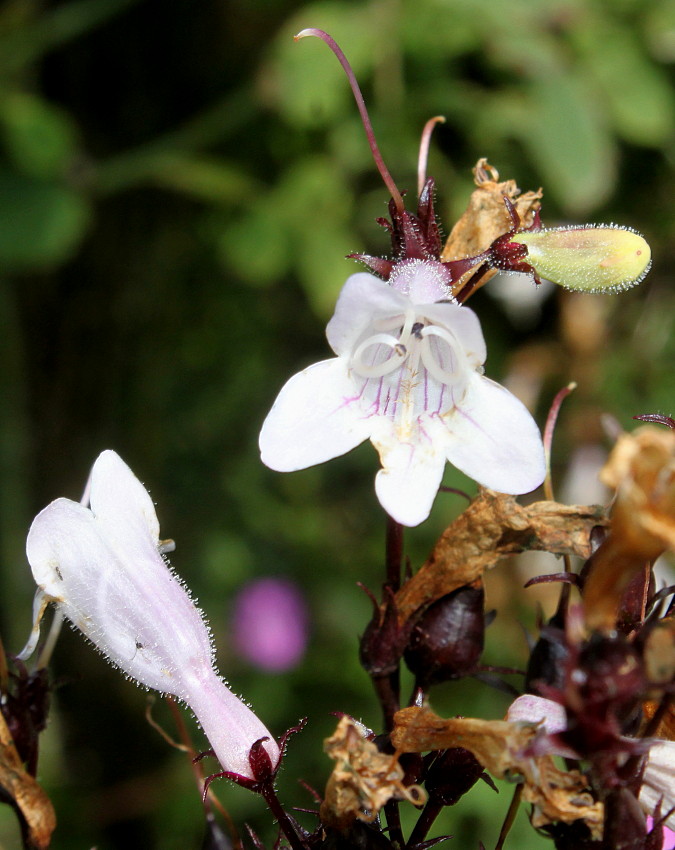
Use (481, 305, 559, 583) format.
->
(260, 268, 545, 526)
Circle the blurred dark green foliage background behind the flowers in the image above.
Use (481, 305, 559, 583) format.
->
(0, 0, 675, 850)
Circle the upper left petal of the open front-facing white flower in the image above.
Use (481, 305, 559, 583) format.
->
(326, 272, 410, 355)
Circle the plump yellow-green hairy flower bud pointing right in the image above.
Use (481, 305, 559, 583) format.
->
(512, 225, 651, 292)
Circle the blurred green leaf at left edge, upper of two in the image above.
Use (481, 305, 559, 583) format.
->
(0, 92, 77, 177)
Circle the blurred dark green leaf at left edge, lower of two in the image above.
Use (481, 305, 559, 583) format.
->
(0, 170, 89, 271)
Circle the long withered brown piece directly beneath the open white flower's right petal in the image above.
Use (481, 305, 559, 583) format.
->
(396, 489, 607, 622)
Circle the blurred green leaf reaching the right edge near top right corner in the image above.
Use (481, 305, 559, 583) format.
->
(575, 17, 675, 146)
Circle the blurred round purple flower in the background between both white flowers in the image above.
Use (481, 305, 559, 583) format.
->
(232, 578, 308, 673)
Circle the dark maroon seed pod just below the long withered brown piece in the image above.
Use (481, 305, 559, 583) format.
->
(405, 584, 485, 687)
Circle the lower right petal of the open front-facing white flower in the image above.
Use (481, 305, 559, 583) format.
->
(444, 373, 546, 494)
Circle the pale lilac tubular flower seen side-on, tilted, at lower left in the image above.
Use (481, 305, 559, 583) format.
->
(26, 451, 279, 778)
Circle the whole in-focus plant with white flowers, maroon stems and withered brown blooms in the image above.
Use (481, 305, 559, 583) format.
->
(0, 29, 675, 850)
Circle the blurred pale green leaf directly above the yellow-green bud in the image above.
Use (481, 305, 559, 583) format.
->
(516, 73, 616, 214)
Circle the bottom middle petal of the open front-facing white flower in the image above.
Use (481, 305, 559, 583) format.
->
(373, 428, 445, 526)
